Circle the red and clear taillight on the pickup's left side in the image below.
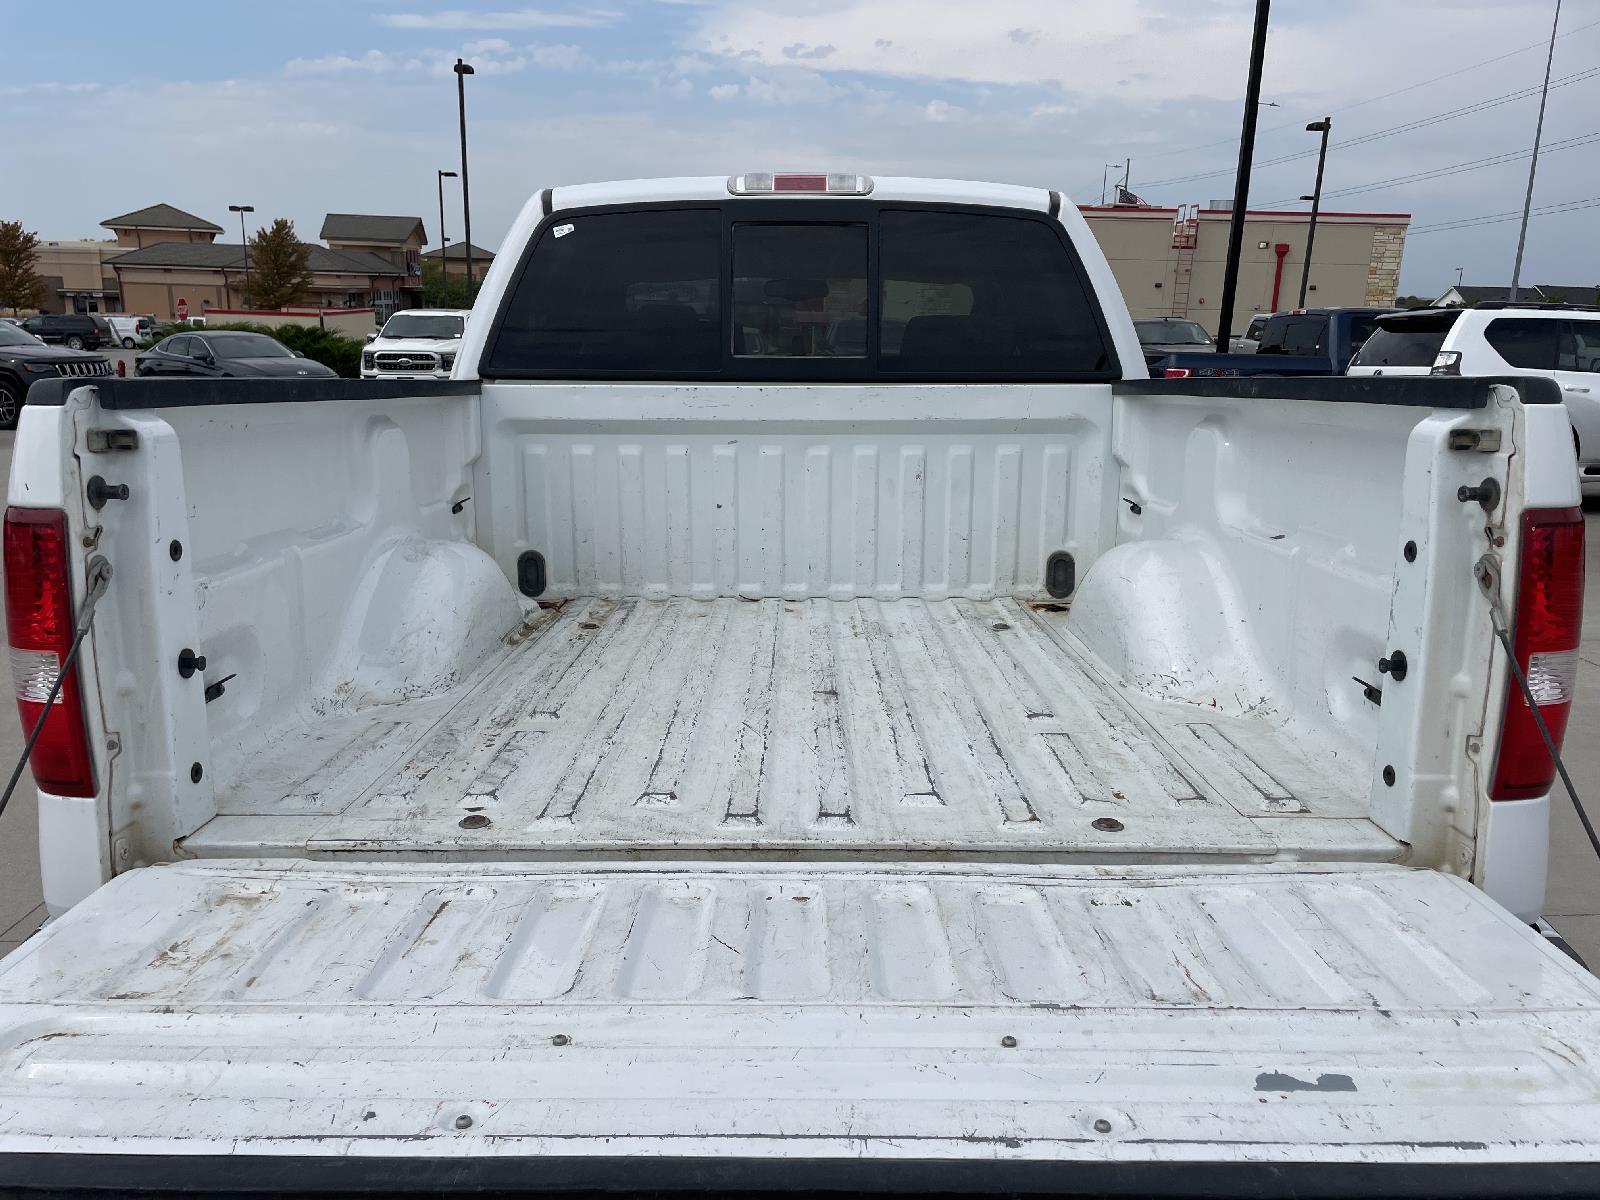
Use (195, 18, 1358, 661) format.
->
(5, 507, 94, 795)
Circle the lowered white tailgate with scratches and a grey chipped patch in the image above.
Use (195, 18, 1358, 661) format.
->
(0, 861, 1600, 1197)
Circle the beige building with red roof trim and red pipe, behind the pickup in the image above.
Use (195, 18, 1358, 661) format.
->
(1080, 205, 1411, 334)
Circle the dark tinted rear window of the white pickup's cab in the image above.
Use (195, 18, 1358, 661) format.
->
(480, 202, 1118, 382)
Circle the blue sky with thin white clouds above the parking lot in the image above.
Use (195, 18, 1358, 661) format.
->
(0, 0, 1600, 293)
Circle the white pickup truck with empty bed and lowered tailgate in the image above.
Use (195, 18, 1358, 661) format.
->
(0, 174, 1600, 1197)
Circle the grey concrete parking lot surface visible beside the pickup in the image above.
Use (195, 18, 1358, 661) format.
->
(0, 432, 1600, 968)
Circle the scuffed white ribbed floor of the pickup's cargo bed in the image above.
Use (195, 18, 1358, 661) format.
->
(181, 598, 1405, 861)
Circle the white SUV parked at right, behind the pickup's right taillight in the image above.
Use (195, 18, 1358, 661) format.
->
(1347, 304, 1600, 496)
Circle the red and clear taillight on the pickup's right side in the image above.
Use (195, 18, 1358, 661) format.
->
(1490, 509, 1584, 800)
